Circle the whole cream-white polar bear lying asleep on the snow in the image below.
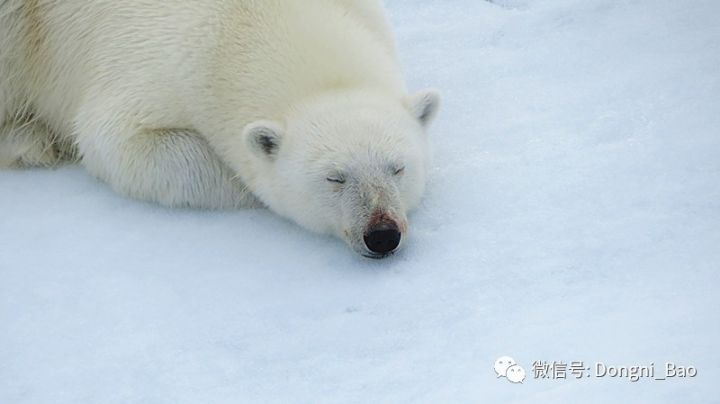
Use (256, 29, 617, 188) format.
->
(0, 0, 439, 258)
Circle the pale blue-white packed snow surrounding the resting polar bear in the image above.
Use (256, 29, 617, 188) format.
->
(0, 0, 720, 404)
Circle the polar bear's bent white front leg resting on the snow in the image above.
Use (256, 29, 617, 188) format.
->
(78, 129, 262, 209)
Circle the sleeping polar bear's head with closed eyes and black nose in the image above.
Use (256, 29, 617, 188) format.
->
(243, 90, 439, 258)
